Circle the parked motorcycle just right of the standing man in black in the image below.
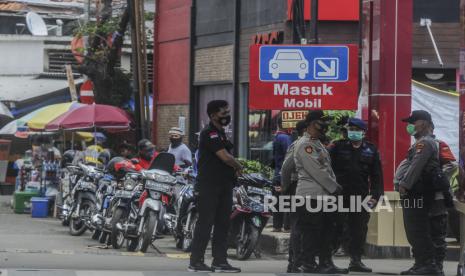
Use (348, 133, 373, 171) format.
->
(228, 174, 272, 260)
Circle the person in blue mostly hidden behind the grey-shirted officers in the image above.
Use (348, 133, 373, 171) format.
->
(273, 116, 292, 232)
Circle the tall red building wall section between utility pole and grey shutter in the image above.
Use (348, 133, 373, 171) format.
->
(152, 0, 192, 142)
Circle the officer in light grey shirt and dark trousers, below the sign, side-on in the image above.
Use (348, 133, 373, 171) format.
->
(293, 110, 348, 274)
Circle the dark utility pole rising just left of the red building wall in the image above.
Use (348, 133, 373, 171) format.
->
(128, 0, 150, 140)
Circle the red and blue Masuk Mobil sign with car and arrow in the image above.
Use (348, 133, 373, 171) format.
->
(249, 45, 358, 110)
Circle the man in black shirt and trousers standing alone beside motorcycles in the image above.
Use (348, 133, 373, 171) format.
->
(188, 100, 242, 272)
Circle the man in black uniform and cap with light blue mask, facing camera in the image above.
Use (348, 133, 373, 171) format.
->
(329, 118, 384, 272)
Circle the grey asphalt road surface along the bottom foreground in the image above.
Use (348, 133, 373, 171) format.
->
(0, 196, 457, 276)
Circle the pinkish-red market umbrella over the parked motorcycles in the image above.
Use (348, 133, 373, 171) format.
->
(45, 104, 131, 131)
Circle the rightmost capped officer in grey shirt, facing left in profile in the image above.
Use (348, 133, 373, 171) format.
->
(395, 110, 450, 275)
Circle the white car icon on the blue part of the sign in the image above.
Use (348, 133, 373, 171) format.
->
(269, 49, 308, 80)
